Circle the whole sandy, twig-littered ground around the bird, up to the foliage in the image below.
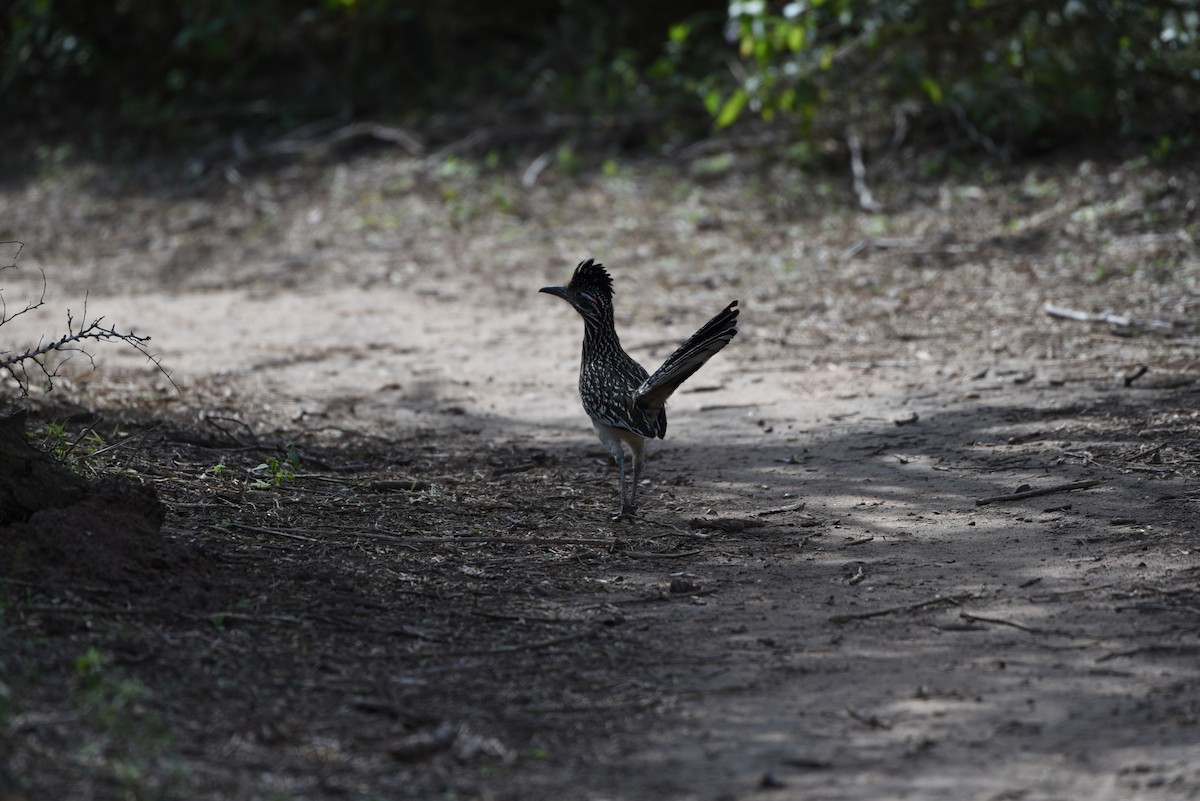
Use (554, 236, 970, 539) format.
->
(0, 146, 1200, 801)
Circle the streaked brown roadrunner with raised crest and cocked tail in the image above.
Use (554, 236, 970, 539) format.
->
(539, 259, 738, 514)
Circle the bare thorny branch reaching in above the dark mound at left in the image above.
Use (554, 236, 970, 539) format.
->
(0, 241, 179, 396)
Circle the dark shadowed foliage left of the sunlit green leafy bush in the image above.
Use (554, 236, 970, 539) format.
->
(0, 0, 724, 145)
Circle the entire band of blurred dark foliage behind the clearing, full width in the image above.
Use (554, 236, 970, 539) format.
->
(0, 0, 1200, 151)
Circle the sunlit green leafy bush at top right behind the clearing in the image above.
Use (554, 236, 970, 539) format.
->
(706, 0, 1200, 147)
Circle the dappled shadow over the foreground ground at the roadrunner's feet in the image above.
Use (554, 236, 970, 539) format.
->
(2, 371, 1200, 799)
